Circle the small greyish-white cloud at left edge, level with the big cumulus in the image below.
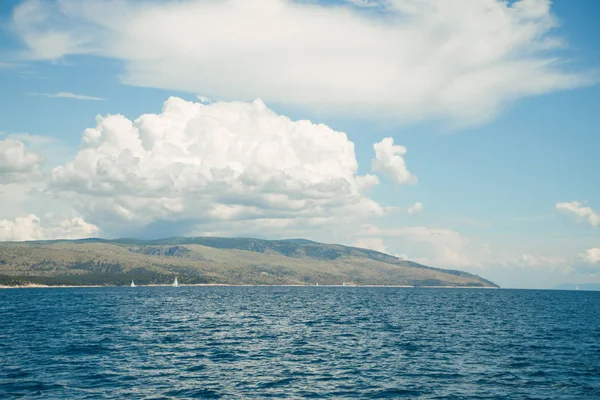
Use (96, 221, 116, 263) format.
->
(0, 139, 44, 184)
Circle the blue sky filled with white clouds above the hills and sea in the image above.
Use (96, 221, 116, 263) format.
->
(0, 0, 600, 288)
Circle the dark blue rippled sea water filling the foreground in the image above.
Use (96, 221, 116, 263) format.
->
(0, 287, 600, 399)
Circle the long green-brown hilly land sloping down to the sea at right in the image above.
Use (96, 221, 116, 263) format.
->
(0, 237, 498, 287)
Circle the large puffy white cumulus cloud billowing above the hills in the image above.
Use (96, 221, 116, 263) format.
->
(51, 97, 385, 233)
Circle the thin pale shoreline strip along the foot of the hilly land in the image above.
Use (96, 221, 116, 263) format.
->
(0, 283, 500, 289)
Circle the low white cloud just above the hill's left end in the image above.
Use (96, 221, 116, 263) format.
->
(0, 214, 99, 241)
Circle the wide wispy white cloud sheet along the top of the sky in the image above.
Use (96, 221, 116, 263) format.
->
(12, 0, 593, 124)
